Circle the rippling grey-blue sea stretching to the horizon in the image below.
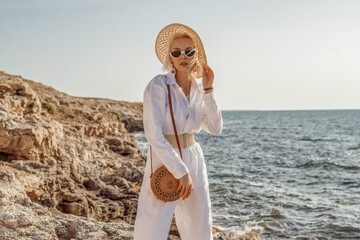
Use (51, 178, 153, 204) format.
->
(135, 110, 360, 240)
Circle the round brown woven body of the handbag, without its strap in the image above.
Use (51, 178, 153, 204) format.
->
(151, 166, 180, 202)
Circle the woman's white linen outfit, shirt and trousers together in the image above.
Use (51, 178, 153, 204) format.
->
(134, 73, 223, 240)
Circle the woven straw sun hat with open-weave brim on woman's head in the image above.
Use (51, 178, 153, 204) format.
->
(155, 23, 207, 78)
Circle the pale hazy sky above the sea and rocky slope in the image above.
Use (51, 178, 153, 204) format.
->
(0, 0, 360, 110)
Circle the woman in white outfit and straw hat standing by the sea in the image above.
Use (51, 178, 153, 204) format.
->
(134, 24, 223, 240)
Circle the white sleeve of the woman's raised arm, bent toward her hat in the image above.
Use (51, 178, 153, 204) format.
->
(201, 92, 223, 135)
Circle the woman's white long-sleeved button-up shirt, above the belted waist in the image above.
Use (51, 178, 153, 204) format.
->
(143, 73, 223, 179)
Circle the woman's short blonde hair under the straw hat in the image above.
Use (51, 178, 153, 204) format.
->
(162, 32, 201, 78)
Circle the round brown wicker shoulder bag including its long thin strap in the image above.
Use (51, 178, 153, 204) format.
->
(150, 76, 184, 202)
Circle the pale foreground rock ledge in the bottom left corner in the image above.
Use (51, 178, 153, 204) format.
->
(0, 169, 133, 240)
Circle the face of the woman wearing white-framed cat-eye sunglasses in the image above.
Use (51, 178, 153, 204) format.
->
(170, 37, 197, 72)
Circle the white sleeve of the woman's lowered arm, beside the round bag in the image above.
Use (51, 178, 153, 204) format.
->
(143, 77, 189, 179)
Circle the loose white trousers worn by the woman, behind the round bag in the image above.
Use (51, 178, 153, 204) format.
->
(134, 143, 213, 240)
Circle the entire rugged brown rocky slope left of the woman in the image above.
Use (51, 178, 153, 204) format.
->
(0, 72, 145, 239)
